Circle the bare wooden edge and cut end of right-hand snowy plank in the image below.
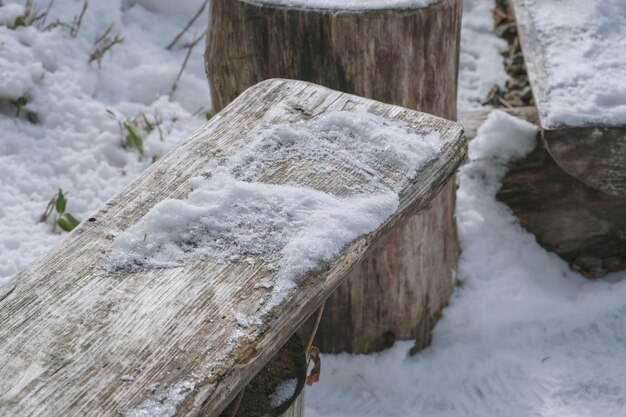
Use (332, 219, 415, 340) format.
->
(512, 0, 626, 197)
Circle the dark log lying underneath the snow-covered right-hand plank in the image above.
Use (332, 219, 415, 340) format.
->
(459, 108, 626, 277)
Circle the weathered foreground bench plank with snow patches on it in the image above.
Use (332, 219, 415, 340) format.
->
(0, 80, 466, 417)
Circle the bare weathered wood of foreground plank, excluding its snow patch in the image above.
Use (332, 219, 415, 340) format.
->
(0, 80, 466, 417)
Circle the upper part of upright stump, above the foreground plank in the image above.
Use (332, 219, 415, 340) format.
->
(205, 0, 462, 119)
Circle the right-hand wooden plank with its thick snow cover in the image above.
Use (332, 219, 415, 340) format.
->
(513, 0, 626, 196)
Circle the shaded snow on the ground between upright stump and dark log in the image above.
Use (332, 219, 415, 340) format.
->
(305, 112, 626, 417)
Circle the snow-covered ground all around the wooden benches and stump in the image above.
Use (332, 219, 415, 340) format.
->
(0, 0, 626, 417)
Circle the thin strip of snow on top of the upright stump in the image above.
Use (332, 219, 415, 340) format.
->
(255, 0, 441, 10)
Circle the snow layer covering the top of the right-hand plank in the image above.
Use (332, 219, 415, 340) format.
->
(524, 0, 626, 127)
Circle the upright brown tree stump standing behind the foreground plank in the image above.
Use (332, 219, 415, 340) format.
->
(205, 0, 462, 353)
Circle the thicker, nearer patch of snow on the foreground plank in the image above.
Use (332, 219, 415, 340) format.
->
(112, 168, 399, 278)
